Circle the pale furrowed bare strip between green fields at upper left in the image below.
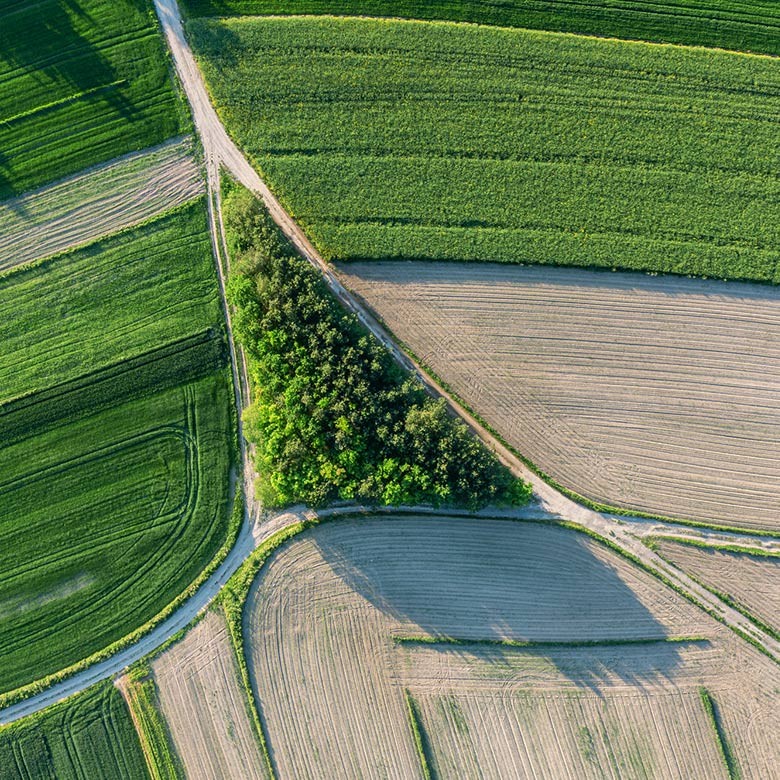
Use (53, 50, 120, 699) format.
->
(0, 138, 205, 273)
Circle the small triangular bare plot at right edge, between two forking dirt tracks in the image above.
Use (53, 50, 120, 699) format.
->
(656, 539, 780, 633)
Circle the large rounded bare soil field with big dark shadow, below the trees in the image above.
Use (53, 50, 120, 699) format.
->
(245, 517, 780, 780)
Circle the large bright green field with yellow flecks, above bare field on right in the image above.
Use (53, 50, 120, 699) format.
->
(189, 17, 780, 282)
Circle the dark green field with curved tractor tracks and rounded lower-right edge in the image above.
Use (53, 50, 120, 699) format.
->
(0, 372, 232, 692)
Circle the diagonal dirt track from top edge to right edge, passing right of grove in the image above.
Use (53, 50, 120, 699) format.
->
(155, 0, 780, 663)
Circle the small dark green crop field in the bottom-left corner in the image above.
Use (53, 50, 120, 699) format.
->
(0, 682, 149, 780)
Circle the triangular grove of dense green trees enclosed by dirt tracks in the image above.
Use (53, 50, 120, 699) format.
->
(225, 185, 530, 508)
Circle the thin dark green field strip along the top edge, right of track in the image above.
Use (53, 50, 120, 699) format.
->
(182, 0, 780, 55)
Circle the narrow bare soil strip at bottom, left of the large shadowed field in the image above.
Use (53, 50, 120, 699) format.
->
(152, 611, 267, 780)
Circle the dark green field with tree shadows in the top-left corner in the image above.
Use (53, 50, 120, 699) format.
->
(0, 0, 190, 200)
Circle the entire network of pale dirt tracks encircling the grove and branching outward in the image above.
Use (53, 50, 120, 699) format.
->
(0, 0, 780, 725)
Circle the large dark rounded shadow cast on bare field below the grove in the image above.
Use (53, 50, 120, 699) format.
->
(315, 518, 691, 689)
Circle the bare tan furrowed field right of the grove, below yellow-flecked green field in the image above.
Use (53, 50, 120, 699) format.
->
(340, 262, 780, 531)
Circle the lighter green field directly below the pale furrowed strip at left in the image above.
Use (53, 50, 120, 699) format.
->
(0, 199, 222, 403)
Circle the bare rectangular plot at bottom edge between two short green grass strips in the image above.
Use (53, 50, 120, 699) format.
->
(417, 688, 729, 780)
